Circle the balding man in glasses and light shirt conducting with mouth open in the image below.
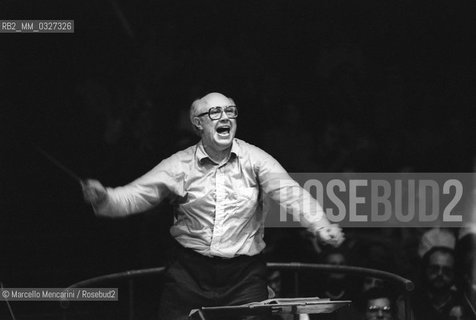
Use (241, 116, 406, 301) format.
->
(83, 93, 343, 320)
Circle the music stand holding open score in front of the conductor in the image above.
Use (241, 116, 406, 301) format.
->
(189, 297, 351, 320)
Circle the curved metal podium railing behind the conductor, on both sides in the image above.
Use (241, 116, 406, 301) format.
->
(65, 262, 415, 320)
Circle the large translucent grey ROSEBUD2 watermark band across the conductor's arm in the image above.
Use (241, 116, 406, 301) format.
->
(266, 173, 476, 228)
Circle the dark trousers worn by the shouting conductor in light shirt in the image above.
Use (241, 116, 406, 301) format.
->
(159, 244, 268, 320)
